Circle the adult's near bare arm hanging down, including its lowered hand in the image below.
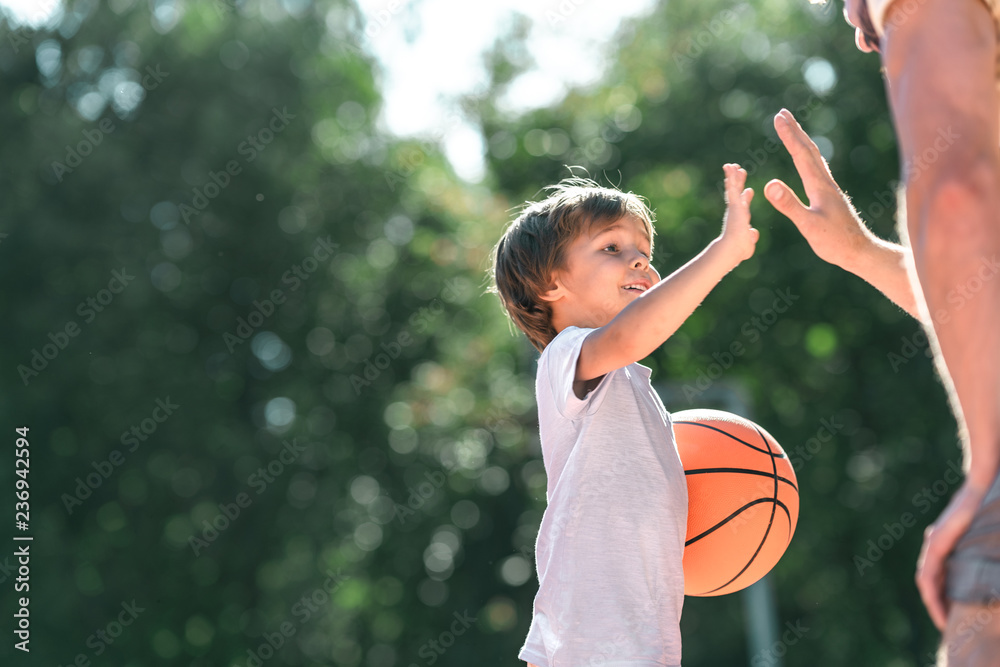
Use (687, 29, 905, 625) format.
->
(881, 0, 1000, 629)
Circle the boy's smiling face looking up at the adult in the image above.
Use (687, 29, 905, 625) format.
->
(542, 215, 660, 332)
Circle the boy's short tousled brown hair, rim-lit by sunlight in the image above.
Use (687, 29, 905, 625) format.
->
(488, 177, 656, 352)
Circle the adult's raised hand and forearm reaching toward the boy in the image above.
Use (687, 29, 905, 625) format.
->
(764, 109, 921, 320)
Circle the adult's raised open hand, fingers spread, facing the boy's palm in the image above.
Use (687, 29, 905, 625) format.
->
(764, 109, 871, 270)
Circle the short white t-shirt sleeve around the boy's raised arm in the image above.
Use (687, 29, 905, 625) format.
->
(538, 327, 616, 419)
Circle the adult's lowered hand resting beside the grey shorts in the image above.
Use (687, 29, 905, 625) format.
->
(916, 481, 987, 632)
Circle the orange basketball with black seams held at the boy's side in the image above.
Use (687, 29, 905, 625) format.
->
(672, 409, 799, 596)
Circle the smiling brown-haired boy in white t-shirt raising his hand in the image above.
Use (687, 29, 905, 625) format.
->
(490, 164, 759, 667)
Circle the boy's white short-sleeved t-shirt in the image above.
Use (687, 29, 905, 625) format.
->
(518, 326, 687, 667)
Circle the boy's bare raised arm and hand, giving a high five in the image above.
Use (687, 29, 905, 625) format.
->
(576, 164, 759, 381)
